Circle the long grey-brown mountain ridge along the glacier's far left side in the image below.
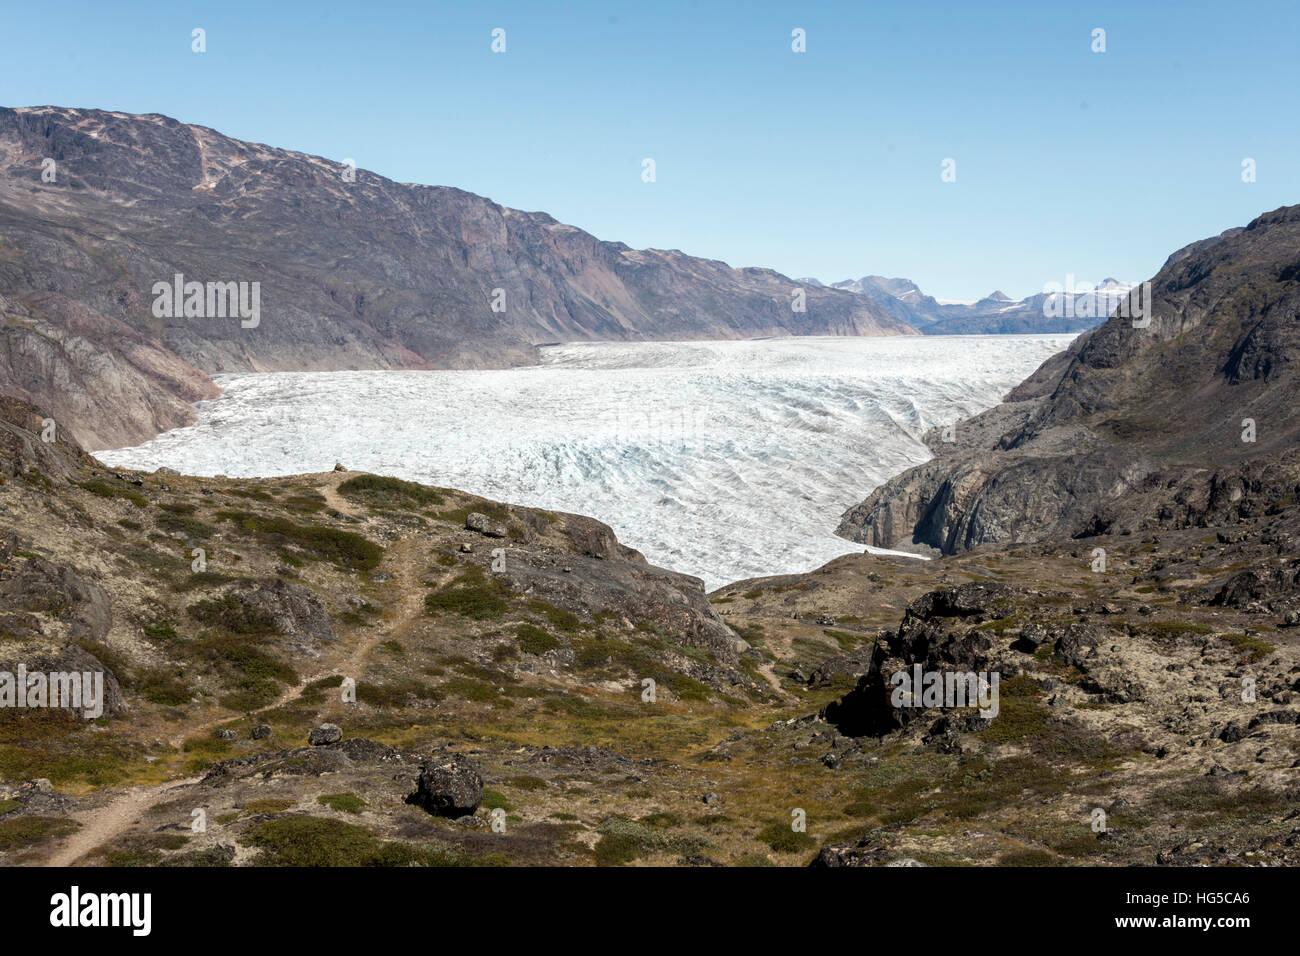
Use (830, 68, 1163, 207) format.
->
(0, 107, 914, 447)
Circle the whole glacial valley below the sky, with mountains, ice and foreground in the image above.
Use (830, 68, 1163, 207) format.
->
(0, 107, 1300, 868)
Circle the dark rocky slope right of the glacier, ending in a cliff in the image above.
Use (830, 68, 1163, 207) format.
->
(839, 207, 1300, 553)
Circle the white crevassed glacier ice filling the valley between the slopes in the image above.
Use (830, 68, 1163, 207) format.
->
(98, 336, 1073, 589)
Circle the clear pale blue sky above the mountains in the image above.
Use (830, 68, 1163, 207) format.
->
(0, 0, 1300, 299)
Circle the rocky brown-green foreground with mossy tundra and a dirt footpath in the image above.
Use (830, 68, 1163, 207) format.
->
(0, 382, 1300, 866)
